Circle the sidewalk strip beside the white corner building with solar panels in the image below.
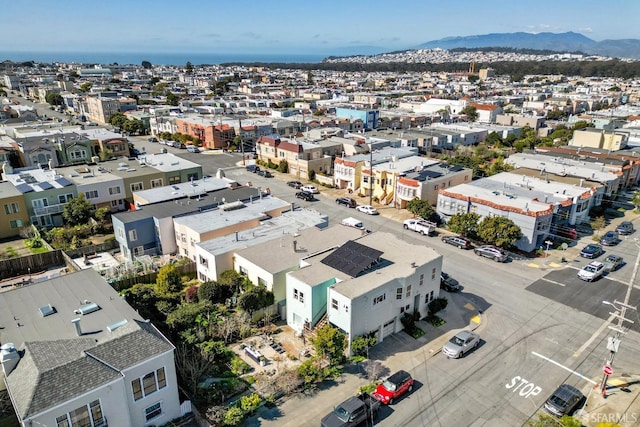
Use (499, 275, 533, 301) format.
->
(245, 293, 483, 427)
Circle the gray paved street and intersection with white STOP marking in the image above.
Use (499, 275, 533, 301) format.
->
(239, 169, 640, 426)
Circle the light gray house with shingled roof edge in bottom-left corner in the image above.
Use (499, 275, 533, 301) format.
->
(0, 269, 182, 427)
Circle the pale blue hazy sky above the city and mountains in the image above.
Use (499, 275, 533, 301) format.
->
(6, 0, 640, 53)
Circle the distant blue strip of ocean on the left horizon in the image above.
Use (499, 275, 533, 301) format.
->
(0, 51, 330, 65)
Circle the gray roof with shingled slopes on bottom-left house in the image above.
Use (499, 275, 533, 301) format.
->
(0, 270, 173, 419)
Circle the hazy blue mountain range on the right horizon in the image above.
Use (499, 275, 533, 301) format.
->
(415, 31, 640, 59)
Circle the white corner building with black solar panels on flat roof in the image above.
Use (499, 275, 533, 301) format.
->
(286, 232, 442, 352)
